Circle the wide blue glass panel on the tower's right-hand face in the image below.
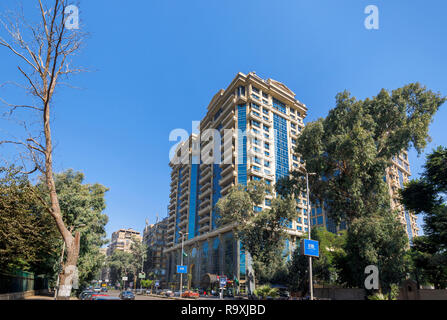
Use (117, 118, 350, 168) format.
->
(273, 113, 289, 181)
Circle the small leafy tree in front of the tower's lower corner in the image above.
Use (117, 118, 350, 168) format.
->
(217, 181, 296, 286)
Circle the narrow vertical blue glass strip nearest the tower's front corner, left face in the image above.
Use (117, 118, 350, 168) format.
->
(237, 104, 247, 185)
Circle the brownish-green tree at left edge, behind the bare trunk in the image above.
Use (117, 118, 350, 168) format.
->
(0, 166, 60, 278)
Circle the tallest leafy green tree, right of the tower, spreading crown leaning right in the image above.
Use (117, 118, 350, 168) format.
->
(278, 83, 446, 289)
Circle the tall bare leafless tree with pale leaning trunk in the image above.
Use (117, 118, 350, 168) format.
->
(0, 0, 85, 299)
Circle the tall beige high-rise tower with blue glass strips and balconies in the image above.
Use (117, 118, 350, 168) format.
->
(165, 72, 307, 287)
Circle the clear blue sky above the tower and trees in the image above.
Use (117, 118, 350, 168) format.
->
(0, 0, 447, 239)
